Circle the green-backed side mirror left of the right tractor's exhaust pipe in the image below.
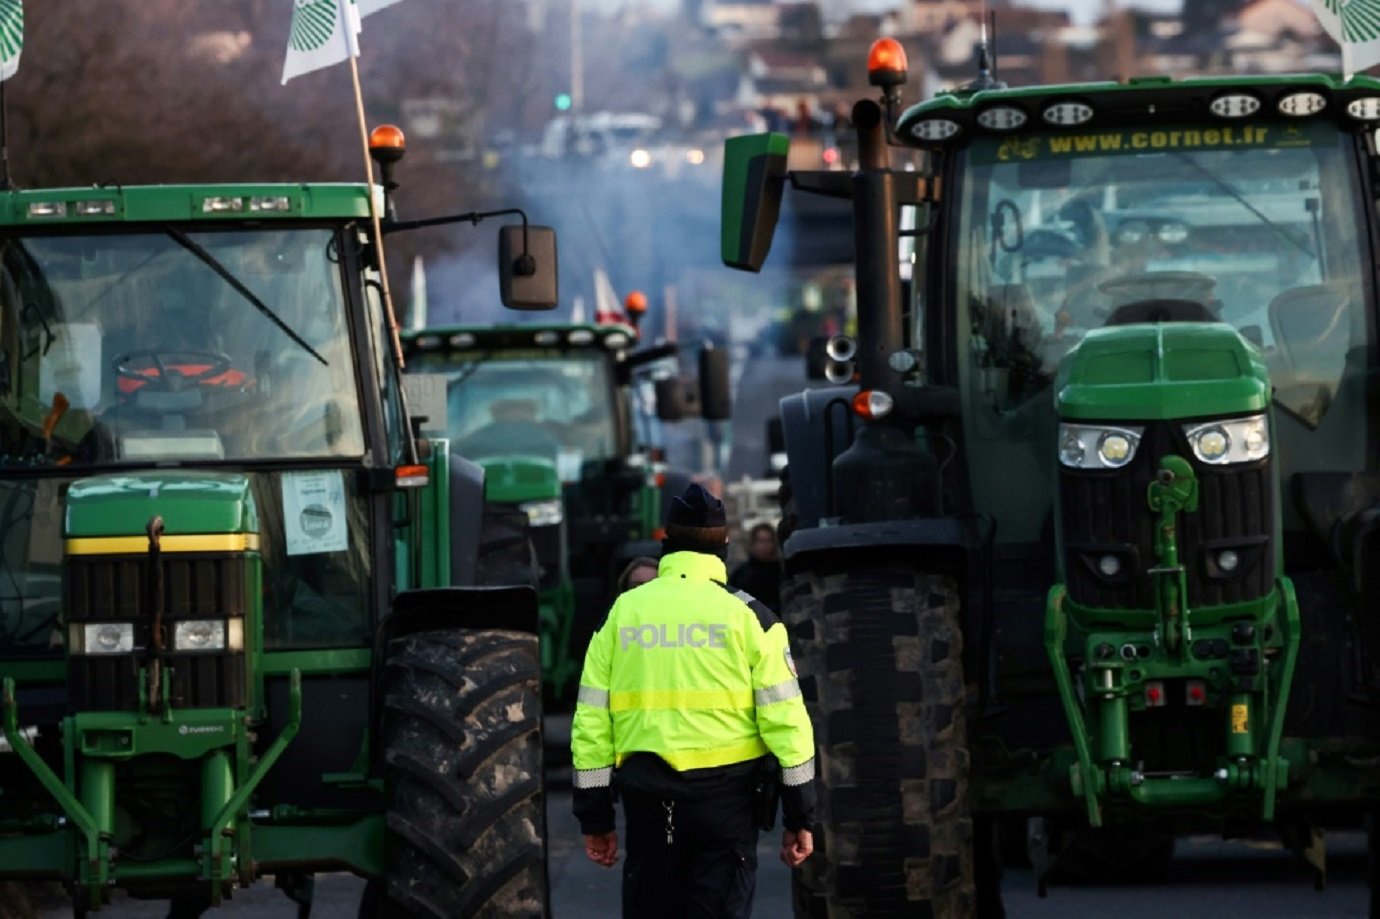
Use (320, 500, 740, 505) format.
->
(719, 134, 791, 272)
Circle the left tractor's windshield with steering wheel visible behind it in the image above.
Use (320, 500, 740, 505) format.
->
(0, 228, 364, 466)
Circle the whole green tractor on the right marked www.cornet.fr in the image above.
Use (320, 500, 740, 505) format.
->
(723, 33, 1380, 916)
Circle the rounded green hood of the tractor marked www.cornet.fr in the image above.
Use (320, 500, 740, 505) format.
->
(1054, 323, 1270, 421)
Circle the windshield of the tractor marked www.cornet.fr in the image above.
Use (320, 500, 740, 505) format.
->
(955, 123, 1366, 428)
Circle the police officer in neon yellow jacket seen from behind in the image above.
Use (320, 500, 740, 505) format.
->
(570, 484, 814, 919)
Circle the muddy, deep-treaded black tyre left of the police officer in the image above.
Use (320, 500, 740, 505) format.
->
(378, 629, 549, 916)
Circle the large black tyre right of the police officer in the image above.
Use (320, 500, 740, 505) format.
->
(782, 566, 976, 919)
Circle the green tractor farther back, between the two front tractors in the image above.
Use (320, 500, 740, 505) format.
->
(403, 313, 731, 708)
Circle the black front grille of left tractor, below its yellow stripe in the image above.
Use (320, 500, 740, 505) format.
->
(66, 552, 248, 711)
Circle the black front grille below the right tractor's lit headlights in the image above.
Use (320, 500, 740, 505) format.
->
(1060, 422, 1275, 610)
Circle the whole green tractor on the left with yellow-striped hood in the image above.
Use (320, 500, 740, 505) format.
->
(0, 134, 555, 916)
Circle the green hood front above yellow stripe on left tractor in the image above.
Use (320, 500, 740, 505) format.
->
(66, 472, 258, 540)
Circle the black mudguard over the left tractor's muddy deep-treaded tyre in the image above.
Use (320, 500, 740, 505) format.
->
(389, 585, 537, 646)
